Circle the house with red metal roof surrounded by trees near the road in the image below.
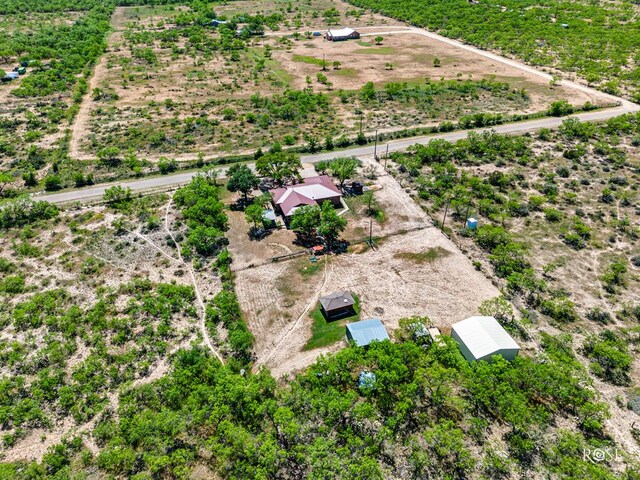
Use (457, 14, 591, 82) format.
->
(271, 175, 342, 221)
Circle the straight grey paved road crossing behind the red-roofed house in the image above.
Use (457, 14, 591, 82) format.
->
(34, 102, 640, 204)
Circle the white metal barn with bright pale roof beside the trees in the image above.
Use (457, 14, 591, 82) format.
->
(451, 317, 520, 362)
